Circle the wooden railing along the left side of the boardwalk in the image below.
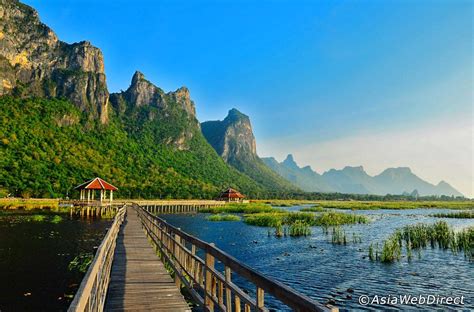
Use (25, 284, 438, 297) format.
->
(68, 206, 126, 312)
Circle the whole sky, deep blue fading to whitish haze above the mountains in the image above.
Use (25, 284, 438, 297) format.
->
(25, 0, 474, 196)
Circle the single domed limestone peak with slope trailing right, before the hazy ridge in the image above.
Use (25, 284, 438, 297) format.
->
(201, 108, 297, 190)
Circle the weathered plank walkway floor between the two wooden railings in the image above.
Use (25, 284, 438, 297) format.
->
(105, 207, 191, 311)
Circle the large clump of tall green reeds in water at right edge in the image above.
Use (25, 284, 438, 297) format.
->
(369, 221, 474, 263)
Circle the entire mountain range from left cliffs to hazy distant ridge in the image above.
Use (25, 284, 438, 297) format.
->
(0, 0, 460, 198)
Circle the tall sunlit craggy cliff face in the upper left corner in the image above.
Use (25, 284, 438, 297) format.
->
(0, 0, 109, 123)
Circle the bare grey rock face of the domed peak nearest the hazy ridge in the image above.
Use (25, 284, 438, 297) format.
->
(201, 108, 257, 162)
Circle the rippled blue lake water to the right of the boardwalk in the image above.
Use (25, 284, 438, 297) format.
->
(161, 206, 474, 310)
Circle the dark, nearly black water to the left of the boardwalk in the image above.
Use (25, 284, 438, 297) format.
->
(0, 211, 111, 312)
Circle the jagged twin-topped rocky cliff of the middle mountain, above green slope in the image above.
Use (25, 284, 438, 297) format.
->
(110, 71, 200, 150)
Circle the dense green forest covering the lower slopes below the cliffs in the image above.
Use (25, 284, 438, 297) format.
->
(0, 96, 266, 198)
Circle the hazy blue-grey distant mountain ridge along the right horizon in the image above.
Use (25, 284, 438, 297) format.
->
(263, 155, 463, 197)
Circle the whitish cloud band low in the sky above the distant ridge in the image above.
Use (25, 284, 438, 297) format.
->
(259, 116, 474, 197)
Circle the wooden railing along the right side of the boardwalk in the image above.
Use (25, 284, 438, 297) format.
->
(134, 204, 337, 312)
